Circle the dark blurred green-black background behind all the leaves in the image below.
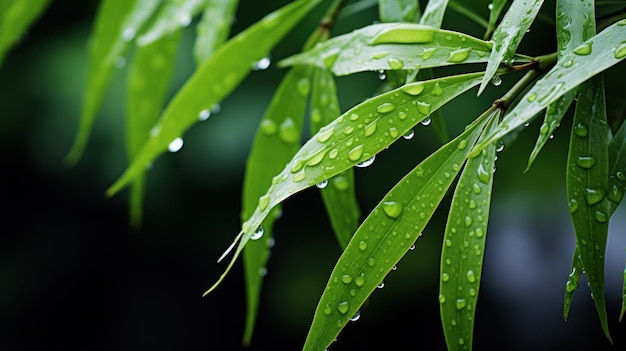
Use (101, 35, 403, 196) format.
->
(0, 0, 626, 351)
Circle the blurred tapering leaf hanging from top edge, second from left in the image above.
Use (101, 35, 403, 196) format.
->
(66, 0, 159, 164)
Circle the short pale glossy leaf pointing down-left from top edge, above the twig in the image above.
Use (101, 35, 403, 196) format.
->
(478, 0, 543, 95)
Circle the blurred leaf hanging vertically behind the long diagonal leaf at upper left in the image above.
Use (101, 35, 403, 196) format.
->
(126, 31, 180, 229)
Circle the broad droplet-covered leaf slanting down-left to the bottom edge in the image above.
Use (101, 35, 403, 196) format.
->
(303, 110, 492, 351)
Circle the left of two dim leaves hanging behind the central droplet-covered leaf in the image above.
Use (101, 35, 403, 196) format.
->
(241, 66, 313, 344)
